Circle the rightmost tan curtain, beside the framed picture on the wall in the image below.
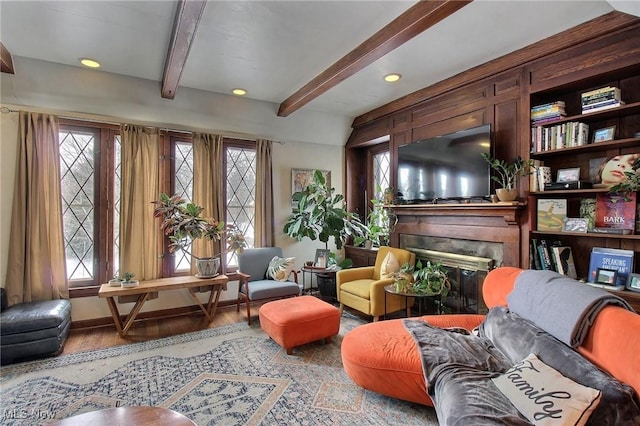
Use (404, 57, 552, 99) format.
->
(254, 139, 275, 247)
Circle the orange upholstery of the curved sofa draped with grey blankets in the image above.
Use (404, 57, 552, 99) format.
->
(341, 267, 640, 406)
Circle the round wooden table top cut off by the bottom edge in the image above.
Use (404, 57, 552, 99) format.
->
(47, 407, 196, 426)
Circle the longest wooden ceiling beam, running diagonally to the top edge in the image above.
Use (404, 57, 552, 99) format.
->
(278, 0, 473, 117)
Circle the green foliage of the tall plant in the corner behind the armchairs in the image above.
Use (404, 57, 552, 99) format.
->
(284, 170, 368, 250)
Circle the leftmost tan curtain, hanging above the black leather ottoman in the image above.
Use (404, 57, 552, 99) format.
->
(6, 111, 69, 305)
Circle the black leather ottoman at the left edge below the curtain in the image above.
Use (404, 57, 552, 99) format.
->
(0, 299, 71, 364)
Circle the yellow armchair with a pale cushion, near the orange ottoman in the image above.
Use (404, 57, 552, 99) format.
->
(336, 246, 416, 321)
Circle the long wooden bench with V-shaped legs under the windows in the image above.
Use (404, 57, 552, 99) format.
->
(98, 275, 229, 337)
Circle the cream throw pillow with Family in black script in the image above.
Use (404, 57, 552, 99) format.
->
(491, 354, 601, 426)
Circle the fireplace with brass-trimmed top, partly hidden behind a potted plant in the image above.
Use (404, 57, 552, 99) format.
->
(404, 246, 494, 314)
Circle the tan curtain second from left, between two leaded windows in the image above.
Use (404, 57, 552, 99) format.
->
(120, 124, 161, 280)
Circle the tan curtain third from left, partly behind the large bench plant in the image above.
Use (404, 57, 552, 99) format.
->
(191, 133, 225, 273)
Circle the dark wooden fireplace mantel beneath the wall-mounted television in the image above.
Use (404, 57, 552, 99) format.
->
(391, 202, 525, 267)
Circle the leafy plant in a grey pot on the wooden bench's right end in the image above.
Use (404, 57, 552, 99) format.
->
(153, 193, 246, 278)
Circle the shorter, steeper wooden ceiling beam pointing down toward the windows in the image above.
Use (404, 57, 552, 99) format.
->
(162, 0, 207, 99)
